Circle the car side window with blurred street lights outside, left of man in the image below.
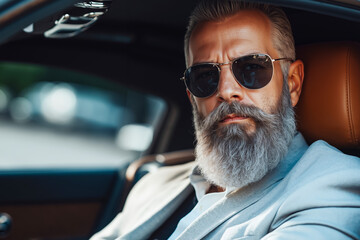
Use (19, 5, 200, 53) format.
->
(0, 62, 167, 169)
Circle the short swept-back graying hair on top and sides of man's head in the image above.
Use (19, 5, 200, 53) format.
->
(184, 0, 295, 74)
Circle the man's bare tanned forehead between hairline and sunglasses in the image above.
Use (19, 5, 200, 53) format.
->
(189, 10, 272, 65)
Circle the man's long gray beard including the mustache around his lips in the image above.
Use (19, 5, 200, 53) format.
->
(193, 84, 296, 188)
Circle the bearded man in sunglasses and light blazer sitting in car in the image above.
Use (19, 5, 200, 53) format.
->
(93, 0, 360, 239)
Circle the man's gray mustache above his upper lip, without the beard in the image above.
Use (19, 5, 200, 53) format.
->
(202, 101, 280, 127)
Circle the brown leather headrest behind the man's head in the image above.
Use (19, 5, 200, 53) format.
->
(295, 42, 360, 151)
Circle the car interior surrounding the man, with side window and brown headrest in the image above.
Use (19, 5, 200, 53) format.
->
(0, 0, 360, 239)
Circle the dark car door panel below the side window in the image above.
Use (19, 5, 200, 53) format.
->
(0, 169, 126, 240)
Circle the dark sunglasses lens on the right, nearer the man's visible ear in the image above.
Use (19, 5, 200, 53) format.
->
(232, 54, 273, 89)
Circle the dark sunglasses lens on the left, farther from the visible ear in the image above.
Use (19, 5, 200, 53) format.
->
(185, 64, 219, 98)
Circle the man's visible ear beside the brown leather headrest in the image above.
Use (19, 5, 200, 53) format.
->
(288, 60, 304, 107)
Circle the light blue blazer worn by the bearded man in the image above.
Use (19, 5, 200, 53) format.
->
(91, 134, 360, 240)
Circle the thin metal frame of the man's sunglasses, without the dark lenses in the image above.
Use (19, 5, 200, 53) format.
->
(180, 53, 294, 98)
